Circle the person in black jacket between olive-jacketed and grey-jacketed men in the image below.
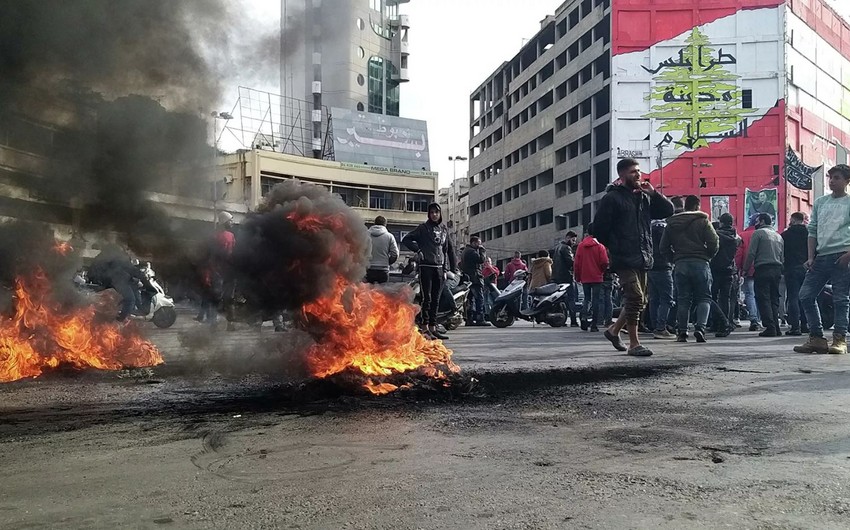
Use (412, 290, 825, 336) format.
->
(711, 212, 741, 337)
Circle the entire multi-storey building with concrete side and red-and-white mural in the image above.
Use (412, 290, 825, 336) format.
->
(469, 0, 850, 258)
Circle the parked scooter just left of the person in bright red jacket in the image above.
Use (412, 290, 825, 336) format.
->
(490, 271, 570, 328)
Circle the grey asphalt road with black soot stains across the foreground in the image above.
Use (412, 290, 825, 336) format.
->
(0, 315, 850, 529)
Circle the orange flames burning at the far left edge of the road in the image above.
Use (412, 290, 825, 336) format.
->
(0, 270, 163, 382)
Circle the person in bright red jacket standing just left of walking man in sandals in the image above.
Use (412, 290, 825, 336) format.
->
(574, 224, 609, 331)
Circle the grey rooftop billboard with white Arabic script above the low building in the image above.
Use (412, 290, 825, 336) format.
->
(331, 108, 431, 171)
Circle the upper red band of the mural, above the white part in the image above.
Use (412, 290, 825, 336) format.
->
(612, 0, 780, 55)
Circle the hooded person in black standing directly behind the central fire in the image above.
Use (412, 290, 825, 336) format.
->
(401, 202, 457, 340)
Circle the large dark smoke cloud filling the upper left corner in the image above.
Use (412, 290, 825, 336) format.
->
(0, 0, 278, 268)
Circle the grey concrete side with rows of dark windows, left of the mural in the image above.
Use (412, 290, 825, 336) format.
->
(469, 0, 611, 261)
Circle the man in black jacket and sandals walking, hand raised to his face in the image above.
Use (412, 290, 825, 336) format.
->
(593, 158, 673, 357)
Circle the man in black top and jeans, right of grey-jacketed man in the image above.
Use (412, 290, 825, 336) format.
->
(782, 212, 809, 336)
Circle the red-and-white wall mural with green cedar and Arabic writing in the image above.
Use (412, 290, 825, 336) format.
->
(611, 0, 785, 225)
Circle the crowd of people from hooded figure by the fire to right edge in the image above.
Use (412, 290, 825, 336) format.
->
(402, 155, 850, 356)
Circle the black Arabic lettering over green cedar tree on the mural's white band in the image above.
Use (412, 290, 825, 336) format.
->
(643, 27, 754, 149)
